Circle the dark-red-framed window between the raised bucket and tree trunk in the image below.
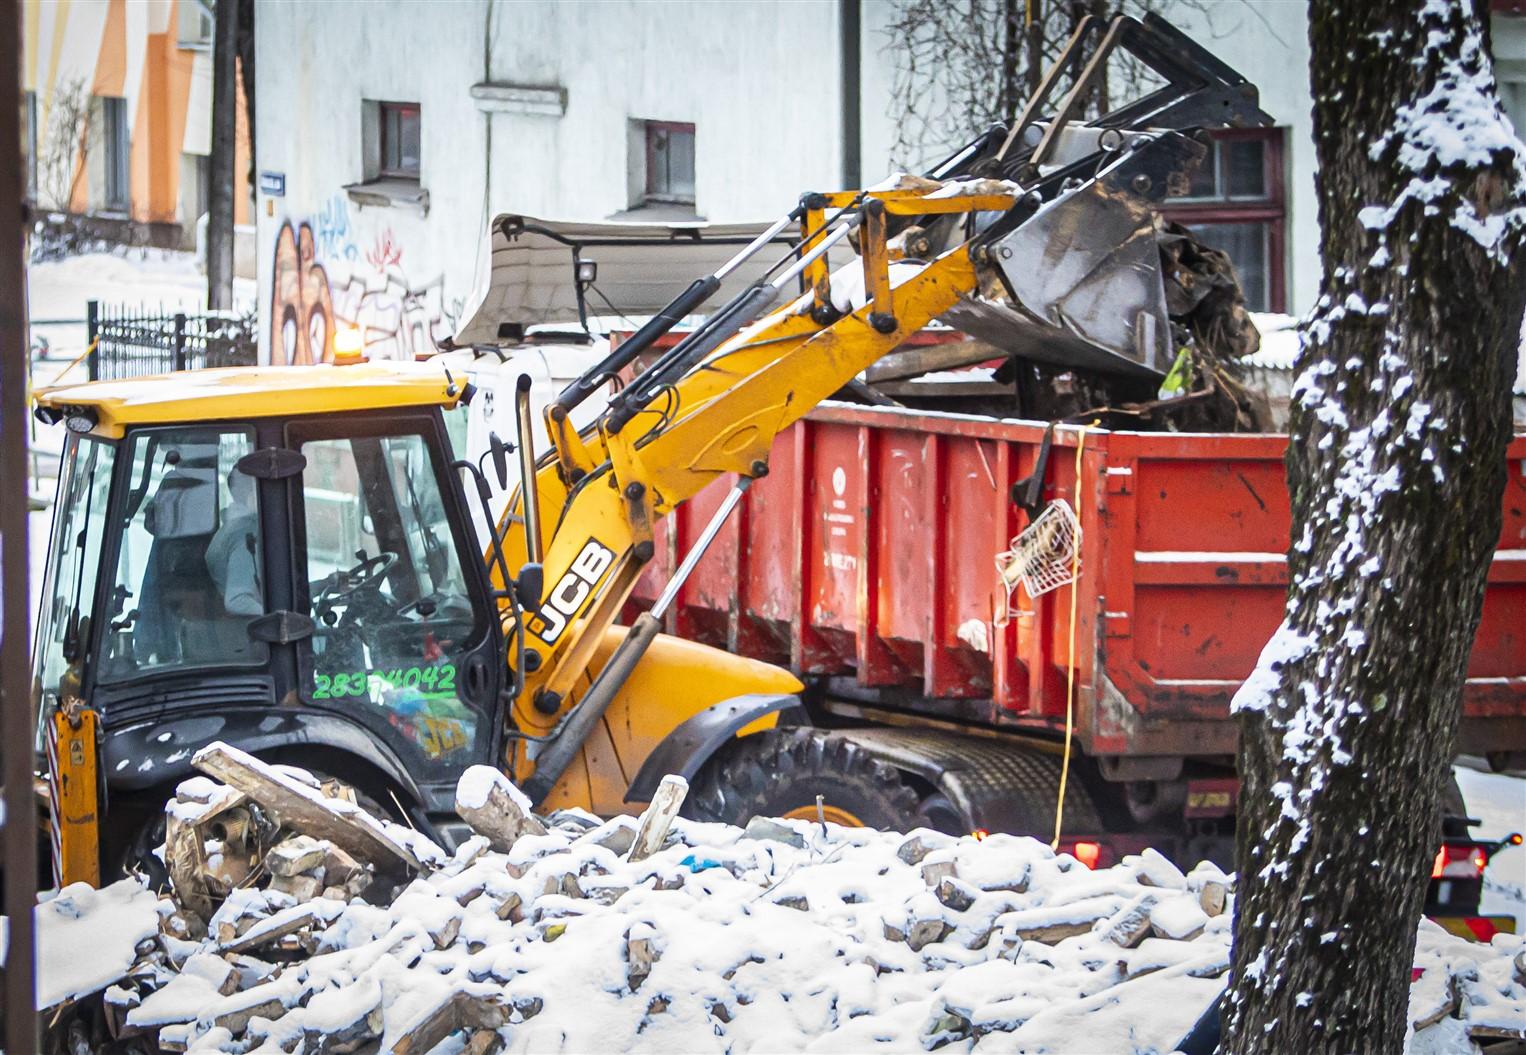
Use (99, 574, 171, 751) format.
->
(1163, 128, 1288, 311)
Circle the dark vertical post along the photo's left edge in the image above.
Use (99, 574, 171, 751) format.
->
(0, 0, 38, 1052)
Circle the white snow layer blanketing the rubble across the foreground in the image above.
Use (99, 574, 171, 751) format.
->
(14, 773, 1526, 1053)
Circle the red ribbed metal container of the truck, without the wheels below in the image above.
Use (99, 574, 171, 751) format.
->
(633, 405, 1526, 757)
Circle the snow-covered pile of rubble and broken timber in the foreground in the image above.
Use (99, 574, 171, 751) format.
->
(38, 744, 1526, 1055)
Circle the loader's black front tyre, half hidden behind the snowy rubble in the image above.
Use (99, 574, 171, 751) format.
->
(687, 728, 920, 831)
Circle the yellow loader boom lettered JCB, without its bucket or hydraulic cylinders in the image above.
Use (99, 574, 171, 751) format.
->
(501, 188, 1015, 776)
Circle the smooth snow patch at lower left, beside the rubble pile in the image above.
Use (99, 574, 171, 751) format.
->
(34, 879, 159, 1008)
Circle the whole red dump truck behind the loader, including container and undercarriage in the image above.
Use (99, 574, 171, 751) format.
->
(633, 377, 1526, 936)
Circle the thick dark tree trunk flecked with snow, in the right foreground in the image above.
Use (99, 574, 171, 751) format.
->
(1221, 0, 1526, 1055)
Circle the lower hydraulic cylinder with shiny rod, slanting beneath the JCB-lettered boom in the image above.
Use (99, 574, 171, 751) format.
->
(525, 476, 752, 803)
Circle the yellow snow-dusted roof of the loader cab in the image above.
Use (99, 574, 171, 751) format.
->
(37, 362, 465, 438)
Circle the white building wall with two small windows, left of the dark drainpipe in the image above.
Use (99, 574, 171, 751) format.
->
(256, 0, 841, 367)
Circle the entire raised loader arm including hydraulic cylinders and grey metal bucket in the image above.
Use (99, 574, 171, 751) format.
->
(479, 10, 1271, 800)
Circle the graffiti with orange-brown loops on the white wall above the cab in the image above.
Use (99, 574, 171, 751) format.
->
(270, 194, 461, 363)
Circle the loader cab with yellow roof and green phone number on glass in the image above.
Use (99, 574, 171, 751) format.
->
(34, 363, 508, 808)
